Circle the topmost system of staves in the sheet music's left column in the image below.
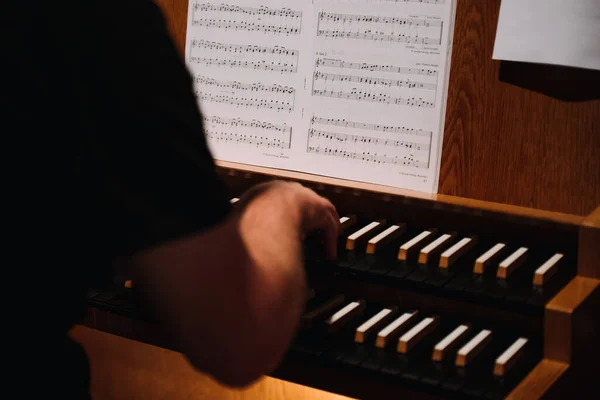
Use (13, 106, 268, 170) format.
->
(192, 3, 302, 35)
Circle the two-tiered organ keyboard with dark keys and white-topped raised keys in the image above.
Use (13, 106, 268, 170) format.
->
(84, 168, 600, 400)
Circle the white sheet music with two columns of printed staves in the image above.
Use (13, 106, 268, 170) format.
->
(186, 0, 455, 192)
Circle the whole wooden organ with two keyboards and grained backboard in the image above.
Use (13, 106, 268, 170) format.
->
(74, 0, 600, 399)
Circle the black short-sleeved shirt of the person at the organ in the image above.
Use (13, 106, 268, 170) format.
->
(5, 0, 230, 398)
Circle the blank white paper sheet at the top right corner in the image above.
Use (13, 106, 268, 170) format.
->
(493, 0, 600, 69)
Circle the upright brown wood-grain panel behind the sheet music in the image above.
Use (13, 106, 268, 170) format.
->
(151, 0, 600, 215)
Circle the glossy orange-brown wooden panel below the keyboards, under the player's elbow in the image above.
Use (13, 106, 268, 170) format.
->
(71, 326, 354, 400)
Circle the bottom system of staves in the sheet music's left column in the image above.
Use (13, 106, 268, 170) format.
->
(204, 116, 292, 149)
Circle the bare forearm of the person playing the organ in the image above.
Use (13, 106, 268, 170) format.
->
(131, 196, 305, 386)
